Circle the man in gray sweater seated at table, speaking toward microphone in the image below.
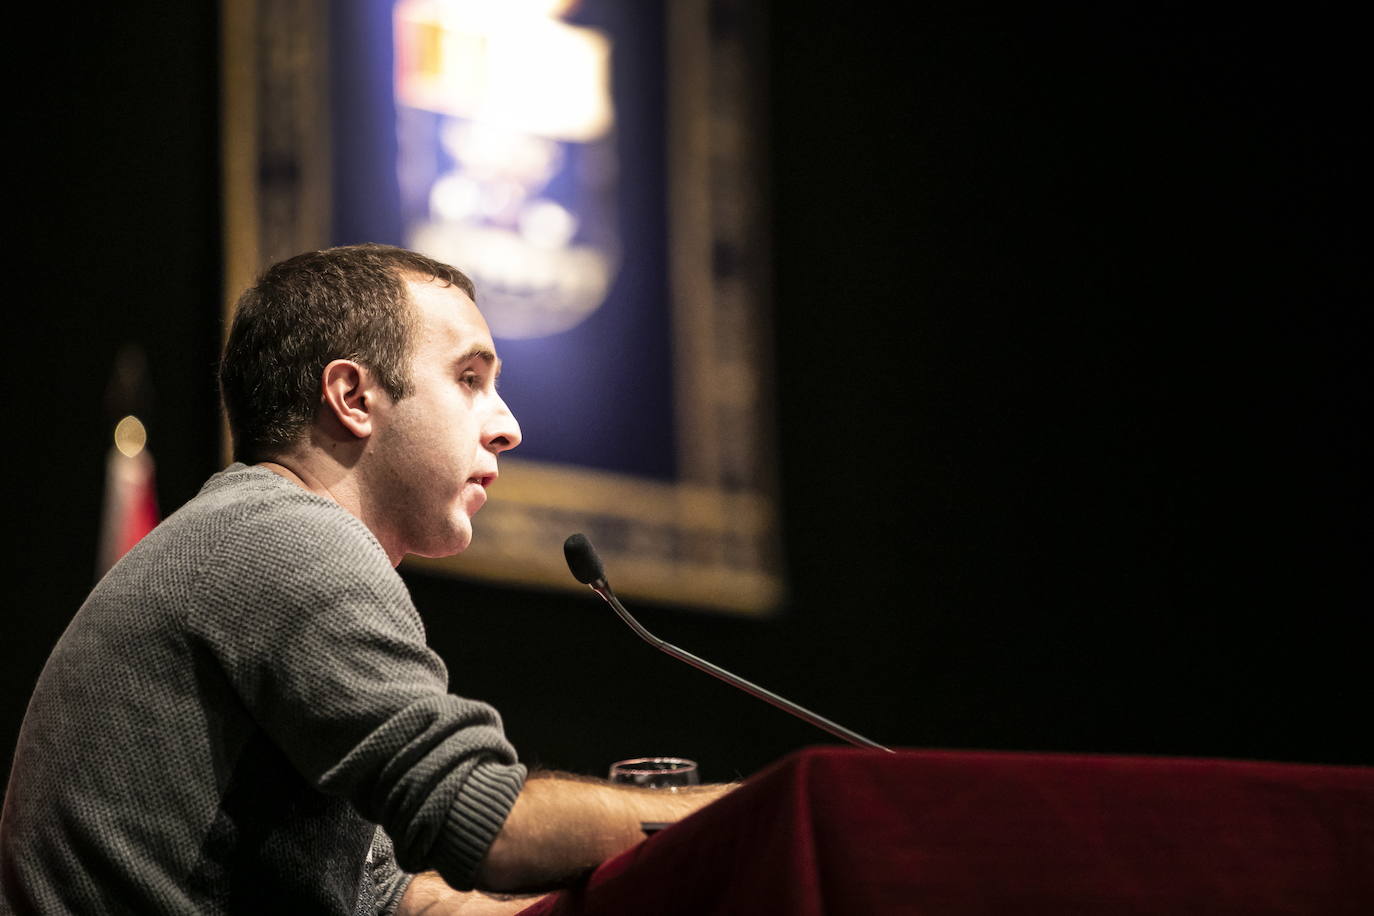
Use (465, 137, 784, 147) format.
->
(0, 244, 724, 913)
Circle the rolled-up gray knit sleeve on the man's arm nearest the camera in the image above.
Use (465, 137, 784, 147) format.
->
(187, 499, 525, 890)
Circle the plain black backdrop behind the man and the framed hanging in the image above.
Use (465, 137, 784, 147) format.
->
(0, 3, 1374, 779)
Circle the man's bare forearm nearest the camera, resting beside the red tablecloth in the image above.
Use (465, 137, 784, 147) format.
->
(477, 773, 734, 890)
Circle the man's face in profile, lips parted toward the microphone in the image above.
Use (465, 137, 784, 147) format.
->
(368, 280, 519, 559)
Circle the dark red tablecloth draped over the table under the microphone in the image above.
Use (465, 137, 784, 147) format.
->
(522, 748, 1374, 916)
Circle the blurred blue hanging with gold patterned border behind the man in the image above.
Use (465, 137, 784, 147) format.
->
(223, 0, 783, 614)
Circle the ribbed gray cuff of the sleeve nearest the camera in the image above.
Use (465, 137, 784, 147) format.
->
(433, 764, 526, 890)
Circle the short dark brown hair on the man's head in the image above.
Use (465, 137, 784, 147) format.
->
(220, 243, 477, 461)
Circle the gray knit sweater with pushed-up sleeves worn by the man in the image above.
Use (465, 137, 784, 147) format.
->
(0, 464, 525, 915)
